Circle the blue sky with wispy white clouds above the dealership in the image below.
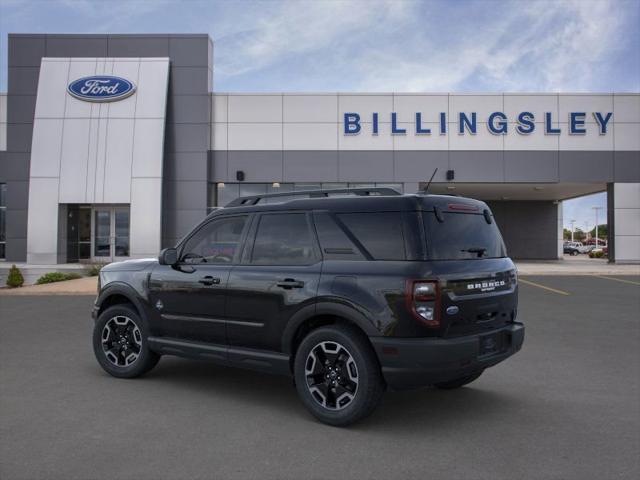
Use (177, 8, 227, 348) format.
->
(0, 0, 640, 225)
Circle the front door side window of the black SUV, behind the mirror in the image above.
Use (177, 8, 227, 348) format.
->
(181, 216, 247, 264)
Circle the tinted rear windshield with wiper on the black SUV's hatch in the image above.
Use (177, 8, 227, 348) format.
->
(423, 212, 507, 260)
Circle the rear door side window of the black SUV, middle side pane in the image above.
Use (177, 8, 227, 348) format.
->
(251, 213, 315, 265)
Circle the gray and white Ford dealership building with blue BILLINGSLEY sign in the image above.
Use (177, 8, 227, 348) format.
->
(0, 34, 640, 265)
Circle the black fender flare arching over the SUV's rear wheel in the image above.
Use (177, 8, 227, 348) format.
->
(282, 300, 380, 355)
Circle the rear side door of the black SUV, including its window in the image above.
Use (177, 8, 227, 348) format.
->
(226, 213, 322, 351)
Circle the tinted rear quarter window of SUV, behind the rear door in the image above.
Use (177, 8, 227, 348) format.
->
(338, 212, 407, 260)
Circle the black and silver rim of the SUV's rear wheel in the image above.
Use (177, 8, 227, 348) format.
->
(304, 342, 359, 410)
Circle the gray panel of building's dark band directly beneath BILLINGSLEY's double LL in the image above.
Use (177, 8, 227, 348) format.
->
(393, 150, 449, 182)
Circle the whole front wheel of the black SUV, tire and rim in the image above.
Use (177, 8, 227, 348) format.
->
(93, 304, 160, 378)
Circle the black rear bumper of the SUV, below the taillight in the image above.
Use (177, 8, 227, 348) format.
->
(370, 323, 524, 390)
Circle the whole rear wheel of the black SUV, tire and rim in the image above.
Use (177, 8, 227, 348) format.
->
(294, 325, 384, 427)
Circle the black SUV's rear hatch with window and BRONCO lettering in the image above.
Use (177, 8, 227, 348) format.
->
(422, 203, 517, 337)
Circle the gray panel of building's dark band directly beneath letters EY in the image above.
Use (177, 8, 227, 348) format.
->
(559, 150, 613, 183)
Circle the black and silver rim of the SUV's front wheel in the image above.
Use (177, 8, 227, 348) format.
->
(101, 315, 142, 367)
